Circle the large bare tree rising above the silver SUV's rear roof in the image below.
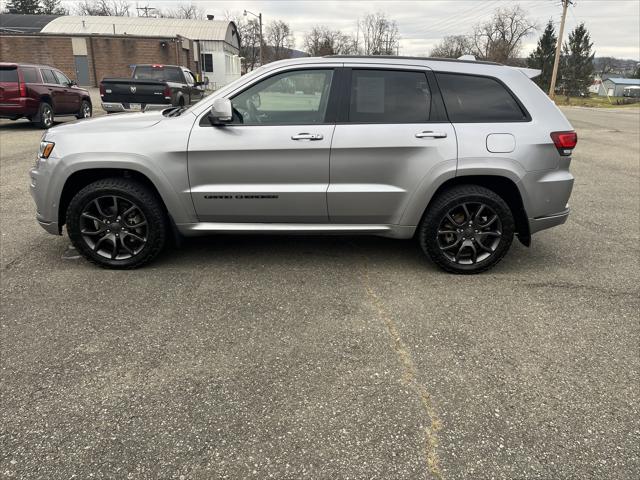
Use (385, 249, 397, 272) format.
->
(472, 5, 537, 64)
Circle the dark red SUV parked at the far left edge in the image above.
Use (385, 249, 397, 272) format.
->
(0, 63, 91, 128)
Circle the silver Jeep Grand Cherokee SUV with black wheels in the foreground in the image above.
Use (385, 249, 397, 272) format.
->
(31, 57, 577, 273)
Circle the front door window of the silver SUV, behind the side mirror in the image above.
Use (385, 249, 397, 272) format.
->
(231, 70, 333, 125)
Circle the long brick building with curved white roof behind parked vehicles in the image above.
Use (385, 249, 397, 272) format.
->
(0, 14, 240, 88)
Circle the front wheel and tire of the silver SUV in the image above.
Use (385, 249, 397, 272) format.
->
(66, 178, 167, 269)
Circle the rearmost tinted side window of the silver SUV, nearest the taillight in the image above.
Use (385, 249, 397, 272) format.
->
(436, 73, 529, 123)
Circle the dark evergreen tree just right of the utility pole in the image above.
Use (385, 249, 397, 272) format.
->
(561, 23, 595, 96)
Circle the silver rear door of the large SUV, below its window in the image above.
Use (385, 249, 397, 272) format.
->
(327, 123, 457, 224)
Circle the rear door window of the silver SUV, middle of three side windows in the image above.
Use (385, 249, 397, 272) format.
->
(349, 70, 431, 123)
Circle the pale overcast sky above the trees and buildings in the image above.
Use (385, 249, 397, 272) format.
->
(55, 0, 640, 60)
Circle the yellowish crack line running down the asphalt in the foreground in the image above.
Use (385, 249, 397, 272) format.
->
(364, 258, 444, 480)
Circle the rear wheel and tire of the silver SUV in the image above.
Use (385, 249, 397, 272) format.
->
(418, 185, 515, 274)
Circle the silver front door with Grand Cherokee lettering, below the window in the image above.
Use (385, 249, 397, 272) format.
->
(189, 125, 335, 223)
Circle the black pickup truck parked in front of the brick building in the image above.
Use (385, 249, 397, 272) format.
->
(100, 64, 204, 113)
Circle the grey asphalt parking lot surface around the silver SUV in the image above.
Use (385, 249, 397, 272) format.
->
(0, 104, 640, 479)
